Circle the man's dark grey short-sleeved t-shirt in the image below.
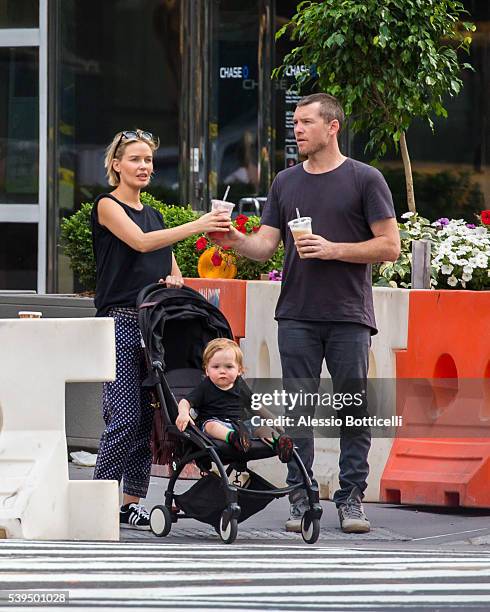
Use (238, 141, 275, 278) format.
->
(261, 158, 395, 334)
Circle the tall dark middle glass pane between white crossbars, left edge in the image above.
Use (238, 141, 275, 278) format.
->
(0, 47, 39, 206)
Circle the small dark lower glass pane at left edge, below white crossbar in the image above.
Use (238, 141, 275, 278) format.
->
(0, 223, 37, 290)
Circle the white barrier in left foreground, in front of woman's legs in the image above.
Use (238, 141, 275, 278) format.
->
(0, 318, 119, 540)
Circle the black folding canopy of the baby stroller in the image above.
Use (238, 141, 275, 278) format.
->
(136, 284, 233, 371)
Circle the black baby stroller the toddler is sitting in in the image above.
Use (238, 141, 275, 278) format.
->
(137, 284, 322, 544)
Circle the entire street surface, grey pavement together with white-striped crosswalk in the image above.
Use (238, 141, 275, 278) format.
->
(0, 465, 490, 612)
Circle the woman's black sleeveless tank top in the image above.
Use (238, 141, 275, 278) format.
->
(91, 193, 172, 317)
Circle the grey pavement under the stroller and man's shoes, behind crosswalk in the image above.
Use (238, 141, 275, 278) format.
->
(69, 463, 490, 551)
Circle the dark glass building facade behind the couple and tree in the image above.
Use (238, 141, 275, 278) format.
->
(0, 0, 490, 292)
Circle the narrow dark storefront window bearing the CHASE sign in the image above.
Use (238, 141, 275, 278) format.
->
(209, 0, 259, 202)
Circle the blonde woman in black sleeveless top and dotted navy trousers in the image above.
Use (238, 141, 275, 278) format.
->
(92, 130, 230, 529)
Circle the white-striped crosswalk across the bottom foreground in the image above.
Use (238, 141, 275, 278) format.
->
(0, 540, 490, 612)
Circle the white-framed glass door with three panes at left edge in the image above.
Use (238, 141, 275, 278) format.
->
(0, 0, 47, 293)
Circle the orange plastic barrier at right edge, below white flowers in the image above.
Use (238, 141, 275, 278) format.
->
(381, 291, 490, 508)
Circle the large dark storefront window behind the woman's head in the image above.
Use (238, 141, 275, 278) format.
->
(51, 0, 181, 291)
